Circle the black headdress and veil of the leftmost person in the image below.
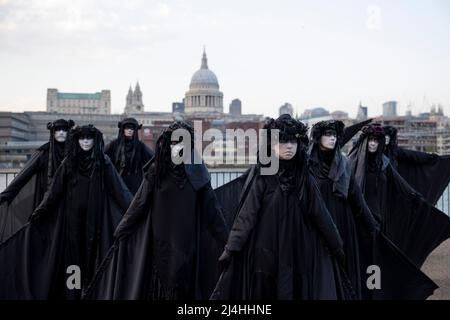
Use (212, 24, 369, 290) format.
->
(47, 119, 75, 184)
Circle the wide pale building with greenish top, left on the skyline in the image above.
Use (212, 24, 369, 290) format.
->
(47, 88, 111, 114)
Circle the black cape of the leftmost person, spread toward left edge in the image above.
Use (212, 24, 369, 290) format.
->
(0, 142, 62, 243)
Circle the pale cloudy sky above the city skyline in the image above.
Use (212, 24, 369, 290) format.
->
(0, 0, 450, 117)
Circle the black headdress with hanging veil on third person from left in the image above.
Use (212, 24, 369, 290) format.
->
(115, 118, 142, 174)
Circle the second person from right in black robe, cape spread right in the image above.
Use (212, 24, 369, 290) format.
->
(349, 124, 450, 267)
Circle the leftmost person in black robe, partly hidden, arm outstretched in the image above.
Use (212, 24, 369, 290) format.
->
(0, 119, 74, 243)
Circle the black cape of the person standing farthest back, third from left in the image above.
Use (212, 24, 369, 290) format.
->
(105, 138, 153, 195)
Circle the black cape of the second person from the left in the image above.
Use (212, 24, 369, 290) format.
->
(0, 156, 132, 299)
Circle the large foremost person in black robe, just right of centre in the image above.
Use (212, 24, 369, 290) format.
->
(211, 114, 352, 300)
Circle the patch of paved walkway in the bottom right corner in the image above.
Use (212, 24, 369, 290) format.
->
(422, 239, 450, 300)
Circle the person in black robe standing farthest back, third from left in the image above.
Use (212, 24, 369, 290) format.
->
(105, 118, 153, 195)
